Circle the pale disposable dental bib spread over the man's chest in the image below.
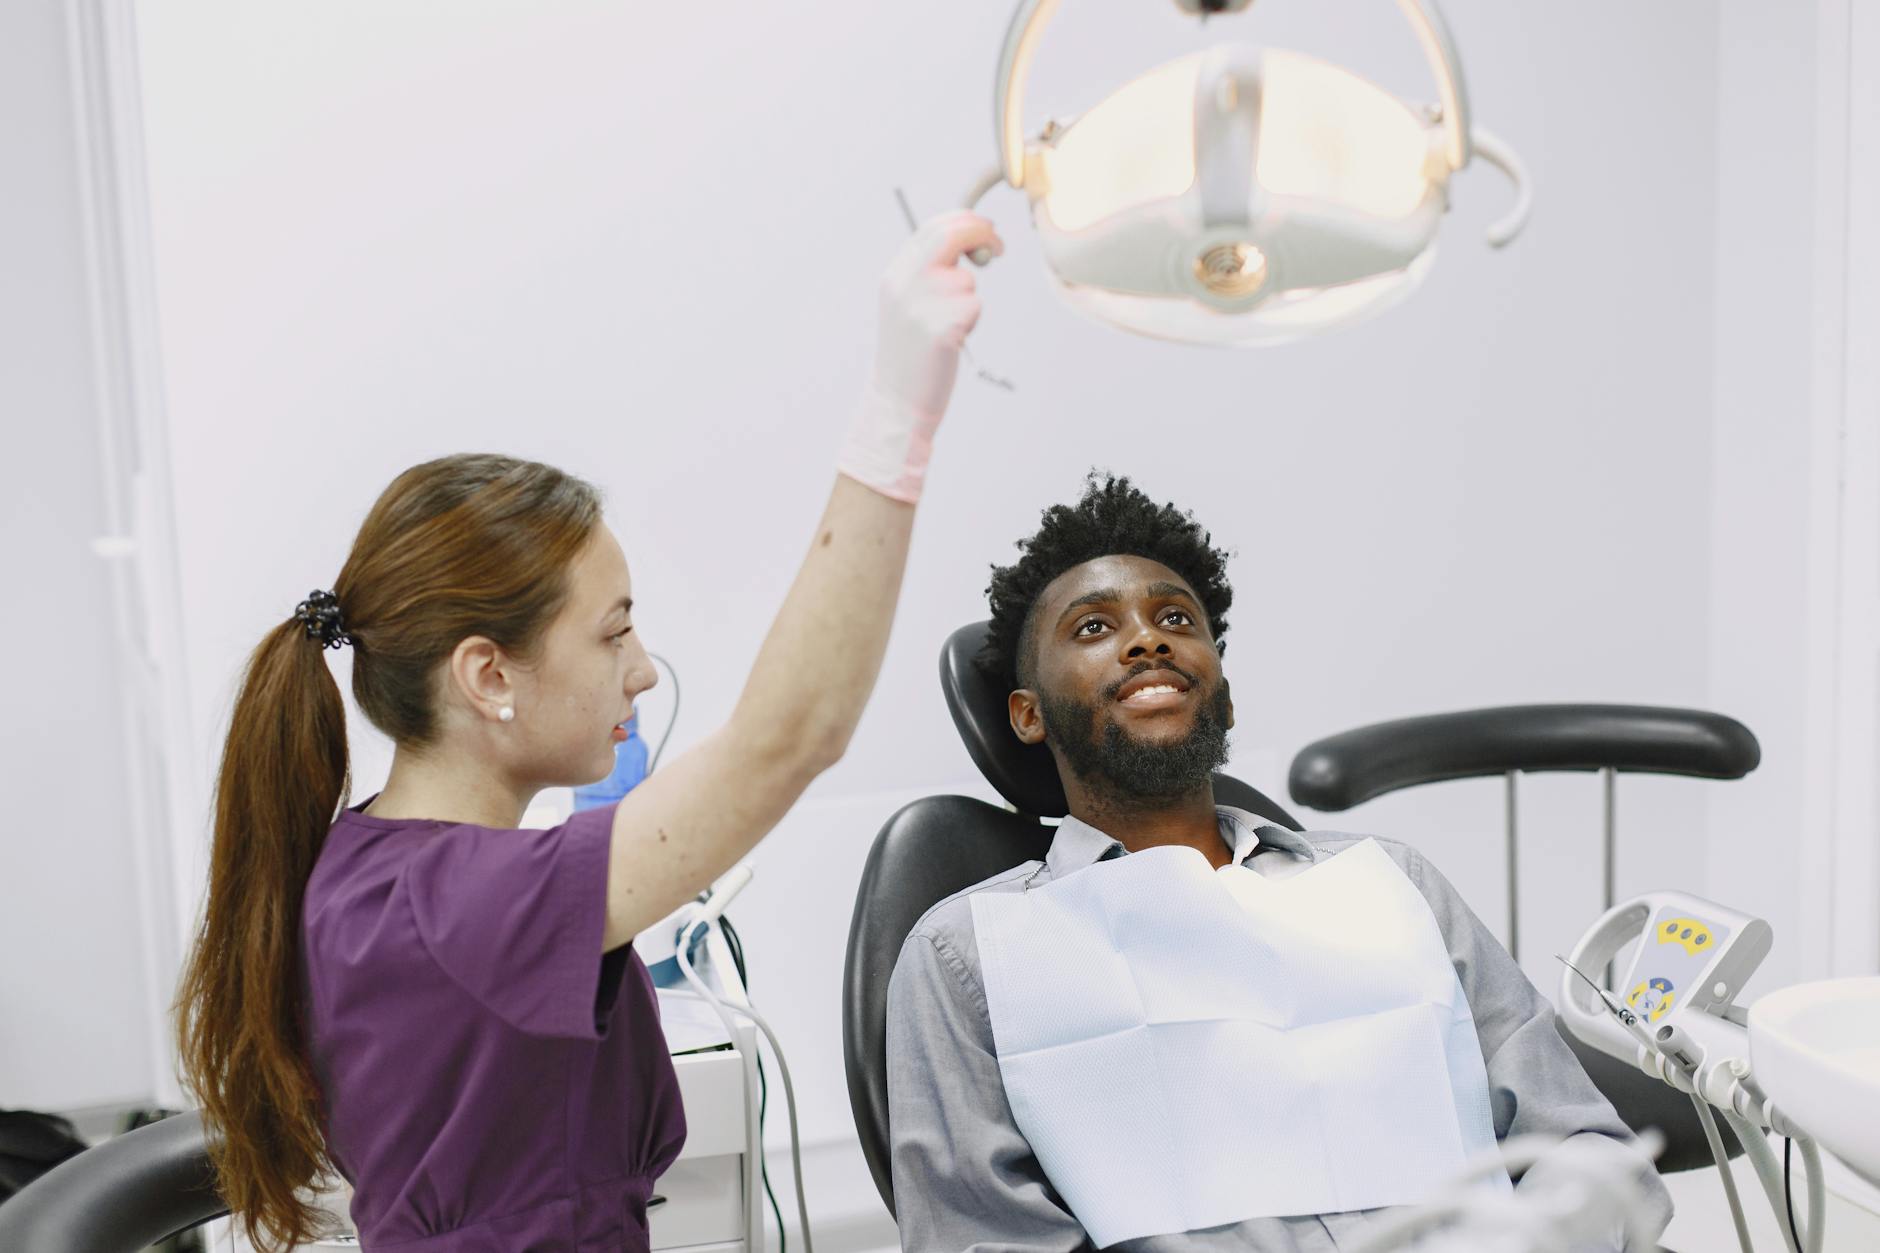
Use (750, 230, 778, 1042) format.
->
(970, 827, 1510, 1247)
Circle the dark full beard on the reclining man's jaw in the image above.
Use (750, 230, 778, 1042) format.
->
(1040, 679, 1230, 807)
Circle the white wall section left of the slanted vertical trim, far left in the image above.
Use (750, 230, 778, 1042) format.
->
(0, 0, 162, 1108)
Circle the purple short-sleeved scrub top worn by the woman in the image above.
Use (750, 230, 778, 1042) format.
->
(301, 801, 686, 1253)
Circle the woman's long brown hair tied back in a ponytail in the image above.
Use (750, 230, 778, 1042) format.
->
(177, 455, 600, 1251)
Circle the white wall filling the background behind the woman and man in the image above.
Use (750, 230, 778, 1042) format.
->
(18, 0, 1880, 1215)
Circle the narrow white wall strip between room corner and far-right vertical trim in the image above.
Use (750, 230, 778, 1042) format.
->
(1707, 4, 1822, 986)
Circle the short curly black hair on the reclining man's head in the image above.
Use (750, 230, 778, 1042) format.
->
(978, 470, 1233, 690)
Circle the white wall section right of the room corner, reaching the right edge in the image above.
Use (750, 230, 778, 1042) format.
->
(1707, 0, 1880, 988)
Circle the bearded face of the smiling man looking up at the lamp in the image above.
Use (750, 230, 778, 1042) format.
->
(1008, 555, 1233, 798)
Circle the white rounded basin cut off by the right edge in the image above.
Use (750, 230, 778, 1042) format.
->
(1750, 976, 1880, 1187)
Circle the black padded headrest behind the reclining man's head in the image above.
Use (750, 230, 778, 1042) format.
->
(940, 623, 1301, 832)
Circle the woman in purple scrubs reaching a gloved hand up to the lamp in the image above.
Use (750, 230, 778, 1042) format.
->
(179, 213, 1000, 1253)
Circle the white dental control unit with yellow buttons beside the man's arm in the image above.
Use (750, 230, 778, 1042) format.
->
(1559, 892, 1801, 1134)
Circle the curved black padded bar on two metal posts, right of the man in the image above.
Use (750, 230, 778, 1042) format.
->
(1288, 706, 1762, 811)
